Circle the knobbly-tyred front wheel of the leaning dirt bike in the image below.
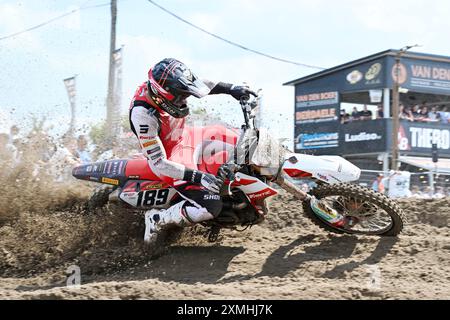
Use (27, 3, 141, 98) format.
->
(303, 183, 406, 236)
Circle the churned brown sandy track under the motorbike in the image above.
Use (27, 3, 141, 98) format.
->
(0, 192, 450, 299)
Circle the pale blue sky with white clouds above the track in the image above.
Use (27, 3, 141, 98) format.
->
(0, 0, 450, 145)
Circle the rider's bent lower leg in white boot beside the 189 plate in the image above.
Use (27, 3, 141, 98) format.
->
(144, 183, 222, 242)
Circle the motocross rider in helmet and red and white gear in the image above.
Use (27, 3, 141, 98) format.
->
(130, 58, 256, 243)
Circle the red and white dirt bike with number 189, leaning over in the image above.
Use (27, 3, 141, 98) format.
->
(73, 98, 405, 242)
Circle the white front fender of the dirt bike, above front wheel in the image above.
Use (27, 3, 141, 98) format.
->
(282, 153, 361, 184)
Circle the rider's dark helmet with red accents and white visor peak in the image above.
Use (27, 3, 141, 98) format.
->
(147, 58, 210, 118)
